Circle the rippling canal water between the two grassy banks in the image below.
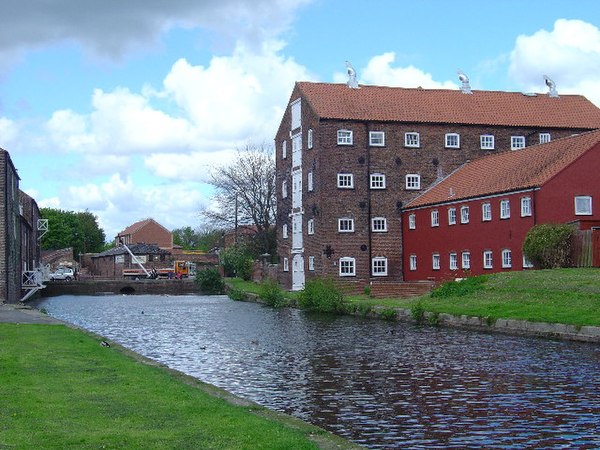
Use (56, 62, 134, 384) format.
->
(38, 295, 600, 449)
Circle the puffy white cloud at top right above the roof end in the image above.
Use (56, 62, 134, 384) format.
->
(509, 19, 600, 105)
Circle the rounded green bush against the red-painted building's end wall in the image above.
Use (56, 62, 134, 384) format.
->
(523, 224, 575, 269)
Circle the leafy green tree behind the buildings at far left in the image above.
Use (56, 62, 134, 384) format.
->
(40, 208, 106, 255)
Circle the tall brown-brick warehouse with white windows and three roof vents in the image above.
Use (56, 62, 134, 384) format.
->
(275, 82, 600, 289)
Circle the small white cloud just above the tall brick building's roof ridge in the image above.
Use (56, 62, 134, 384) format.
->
(334, 52, 457, 89)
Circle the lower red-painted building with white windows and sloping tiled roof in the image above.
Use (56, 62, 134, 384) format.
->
(402, 131, 600, 281)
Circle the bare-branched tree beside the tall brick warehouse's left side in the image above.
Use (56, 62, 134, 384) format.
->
(202, 144, 276, 254)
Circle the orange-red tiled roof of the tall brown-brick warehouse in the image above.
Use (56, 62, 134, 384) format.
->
(292, 82, 600, 130)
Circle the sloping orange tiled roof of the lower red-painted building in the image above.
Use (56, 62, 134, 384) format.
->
(405, 130, 600, 209)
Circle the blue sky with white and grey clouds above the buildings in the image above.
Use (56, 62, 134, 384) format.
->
(0, 0, 600, 239)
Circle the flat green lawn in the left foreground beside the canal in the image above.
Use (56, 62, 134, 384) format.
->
(0, 324, 356, 450)
